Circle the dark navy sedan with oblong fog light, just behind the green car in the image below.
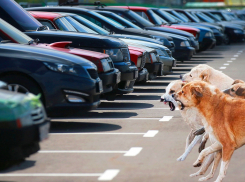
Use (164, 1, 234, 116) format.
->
(0, 43, 103, 116)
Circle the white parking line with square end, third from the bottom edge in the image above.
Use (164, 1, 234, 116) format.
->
(49, 130, 158, 137)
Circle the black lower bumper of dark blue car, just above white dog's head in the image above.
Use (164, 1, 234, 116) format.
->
(173, 47, 195, 61)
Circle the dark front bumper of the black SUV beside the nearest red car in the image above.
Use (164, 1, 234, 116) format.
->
(114, 62, 138, 94)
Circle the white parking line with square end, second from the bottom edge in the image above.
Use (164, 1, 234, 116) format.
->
(38, 147, 142, 156)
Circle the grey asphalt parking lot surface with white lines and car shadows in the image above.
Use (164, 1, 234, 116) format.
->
(0, 43, 245, 182)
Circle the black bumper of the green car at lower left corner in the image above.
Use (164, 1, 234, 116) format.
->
(0, 119, 50, 162)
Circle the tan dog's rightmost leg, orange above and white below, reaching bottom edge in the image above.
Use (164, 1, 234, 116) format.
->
(215, 146, 235, 182)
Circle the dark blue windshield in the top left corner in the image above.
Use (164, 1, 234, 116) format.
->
(0, 0, 42, 31)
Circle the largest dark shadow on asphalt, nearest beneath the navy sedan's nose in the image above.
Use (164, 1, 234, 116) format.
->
(50, 120, 122, 133)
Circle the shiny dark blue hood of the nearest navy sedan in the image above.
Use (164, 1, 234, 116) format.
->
(0, 43, 96, 68)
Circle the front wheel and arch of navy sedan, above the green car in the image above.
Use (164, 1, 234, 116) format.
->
(0, 74, 44, 104)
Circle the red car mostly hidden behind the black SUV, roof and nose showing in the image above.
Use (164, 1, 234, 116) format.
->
(29, 11, 148, 81)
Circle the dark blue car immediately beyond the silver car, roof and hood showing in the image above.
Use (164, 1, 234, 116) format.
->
(27, 7, 174, 52)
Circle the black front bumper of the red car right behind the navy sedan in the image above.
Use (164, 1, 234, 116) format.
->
(99, 69, 121, 94)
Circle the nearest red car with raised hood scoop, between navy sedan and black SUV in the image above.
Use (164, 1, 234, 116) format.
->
(0, 18, 121, 99)
